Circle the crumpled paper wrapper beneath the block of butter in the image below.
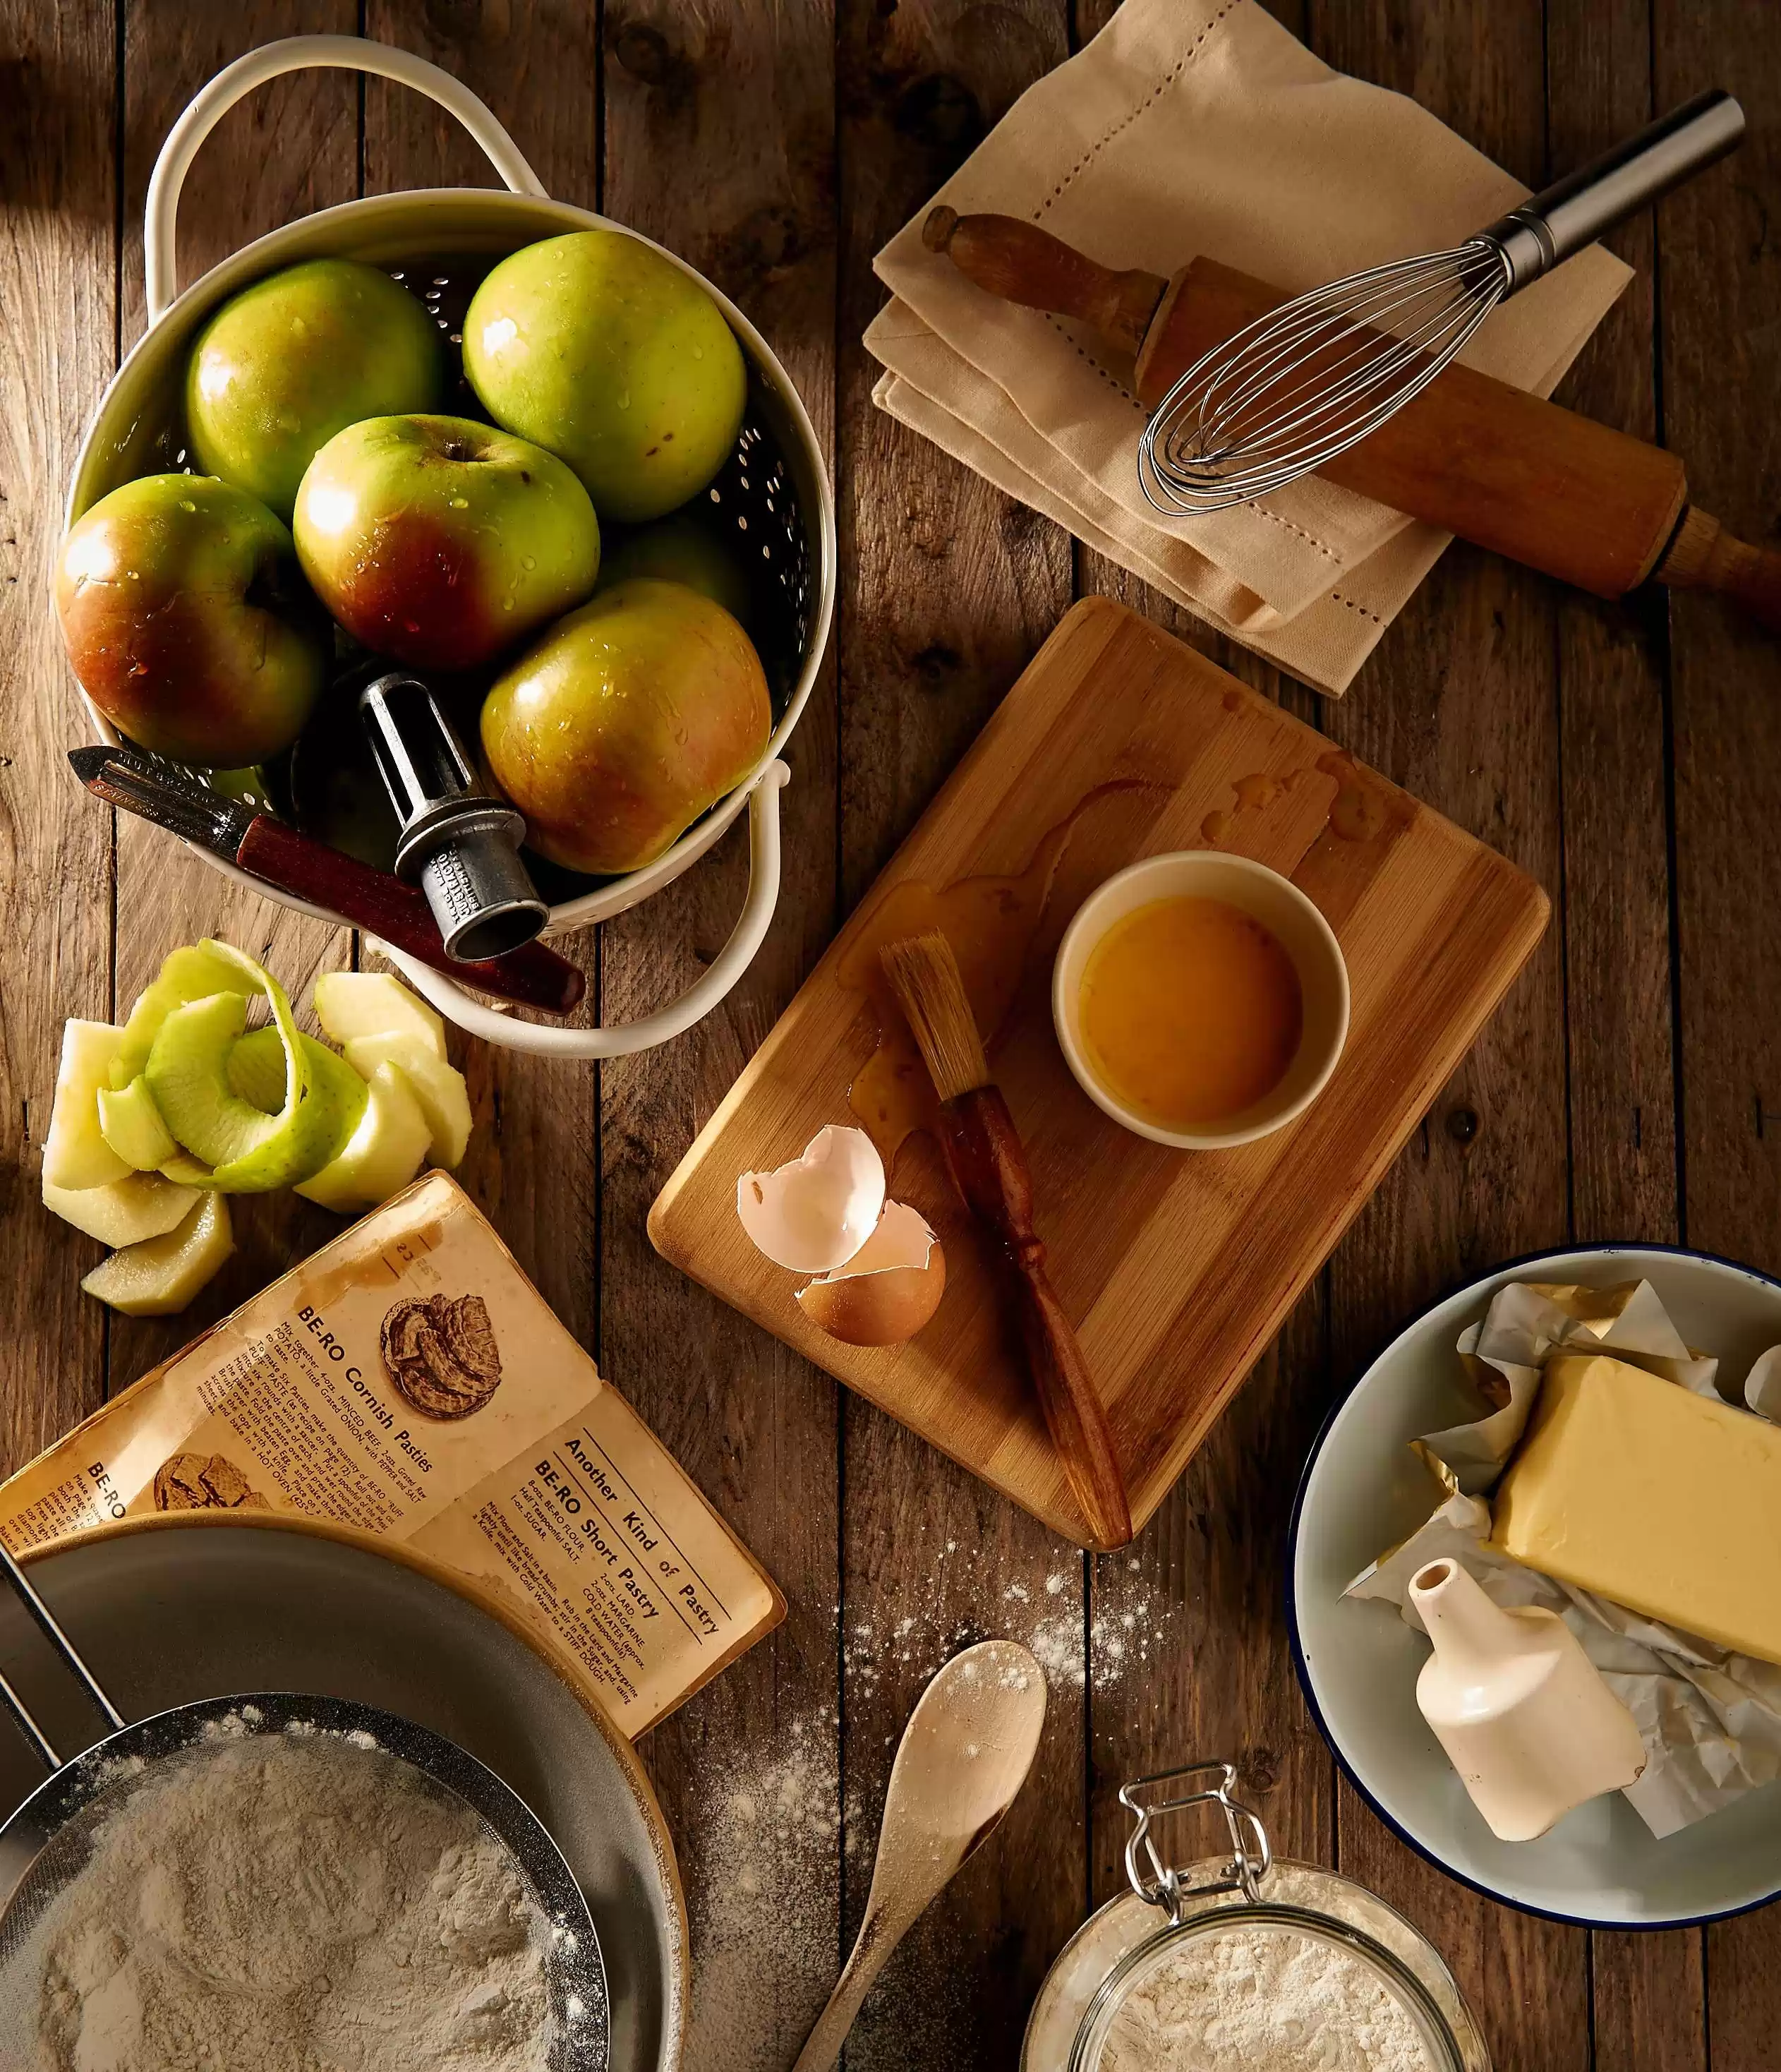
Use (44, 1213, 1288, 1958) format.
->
(1346, 1280, 1781, 1836)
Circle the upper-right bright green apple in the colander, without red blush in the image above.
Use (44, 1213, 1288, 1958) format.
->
(464, 230, 747, 522)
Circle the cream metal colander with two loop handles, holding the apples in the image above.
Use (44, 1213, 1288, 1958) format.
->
(66, 35, 837, 1056)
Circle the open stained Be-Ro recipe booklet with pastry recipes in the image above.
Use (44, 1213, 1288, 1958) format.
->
(0, 1173, 785, 1736)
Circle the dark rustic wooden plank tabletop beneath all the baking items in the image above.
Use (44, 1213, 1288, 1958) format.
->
(0, 0, 1781, 2072)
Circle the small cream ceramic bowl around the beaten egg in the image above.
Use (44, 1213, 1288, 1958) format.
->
(1052, 850, 1348, 1152)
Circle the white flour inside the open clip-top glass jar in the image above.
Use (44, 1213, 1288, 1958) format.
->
(1099, 1929, 1433, 2072)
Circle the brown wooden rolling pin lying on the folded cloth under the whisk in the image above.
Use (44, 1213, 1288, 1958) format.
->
(922, 207, 1781, 632)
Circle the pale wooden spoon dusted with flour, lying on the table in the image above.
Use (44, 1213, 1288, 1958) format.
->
(791, 1641, 1046, 2072)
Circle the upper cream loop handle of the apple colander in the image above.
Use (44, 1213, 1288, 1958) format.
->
(143, 35, 547, 323)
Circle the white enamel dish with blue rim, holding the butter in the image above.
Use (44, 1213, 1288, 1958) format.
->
(1286, 1246, 1781, 1929)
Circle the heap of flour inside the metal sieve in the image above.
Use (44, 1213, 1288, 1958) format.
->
(0, 1730, 553, 2072)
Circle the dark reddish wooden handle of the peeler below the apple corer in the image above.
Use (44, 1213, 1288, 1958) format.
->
(236, 812, 588, 1016)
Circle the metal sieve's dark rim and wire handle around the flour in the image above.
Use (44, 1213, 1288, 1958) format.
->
(0, 1543, 611, 2072)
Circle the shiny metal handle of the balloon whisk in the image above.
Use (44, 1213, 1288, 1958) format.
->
(1475, 87, 1744, 296)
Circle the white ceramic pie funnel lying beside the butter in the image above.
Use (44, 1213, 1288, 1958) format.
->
(1411, 1558, 1644, 1842)
